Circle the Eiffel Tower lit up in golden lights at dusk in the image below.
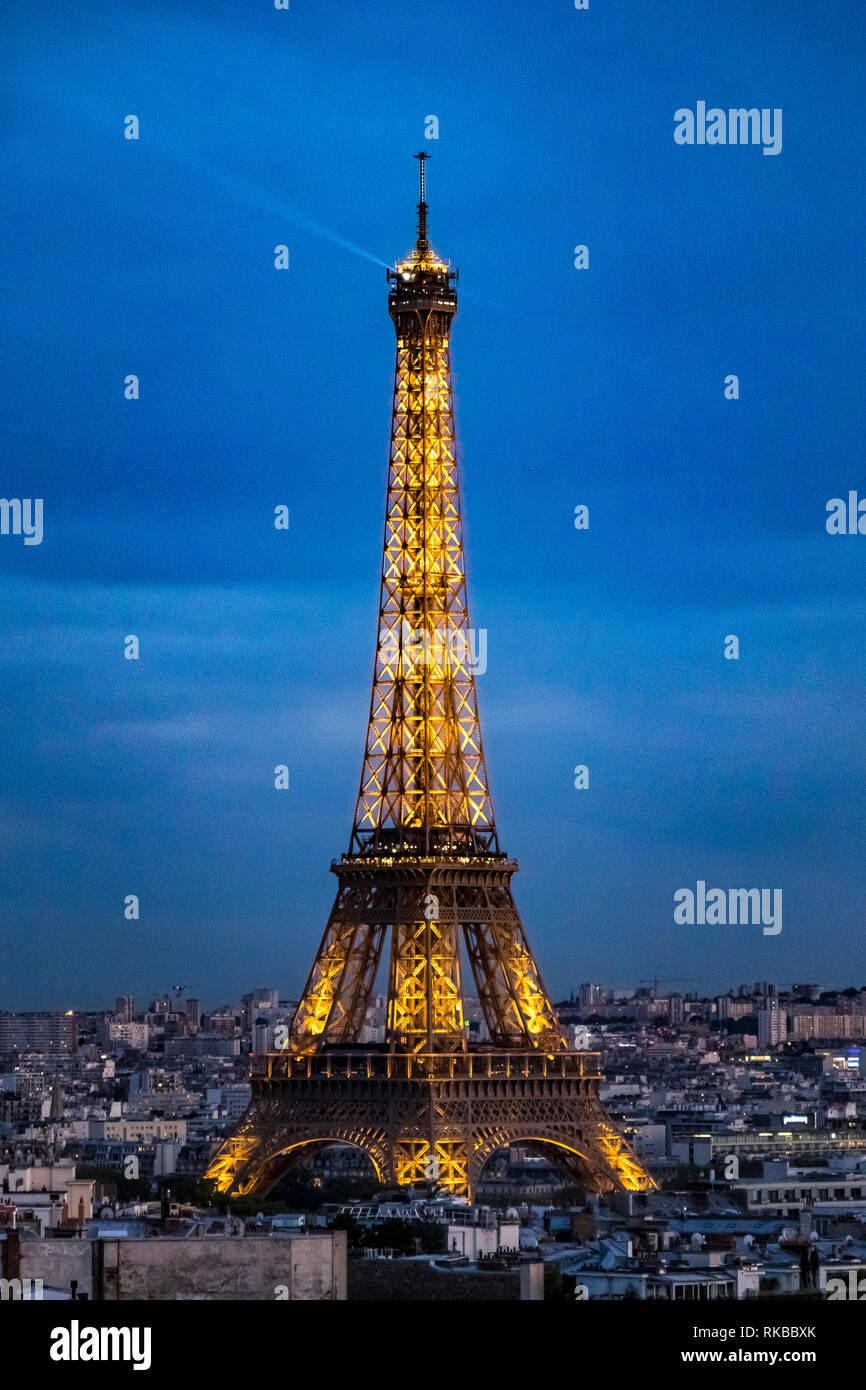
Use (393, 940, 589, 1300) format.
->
(207, 153, 655, 1195)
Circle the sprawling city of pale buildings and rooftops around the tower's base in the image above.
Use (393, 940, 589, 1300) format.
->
(0, 979, 866, 1301)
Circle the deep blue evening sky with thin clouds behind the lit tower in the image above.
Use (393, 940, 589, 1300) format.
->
(0, 0, 866, 1008)
